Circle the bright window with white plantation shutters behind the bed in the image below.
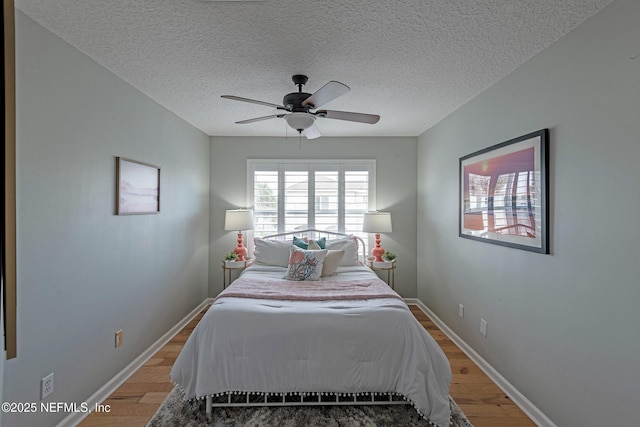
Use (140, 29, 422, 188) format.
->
(247, 160, 375, 241)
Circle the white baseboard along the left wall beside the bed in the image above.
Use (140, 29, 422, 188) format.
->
(56, 298, 213, 427)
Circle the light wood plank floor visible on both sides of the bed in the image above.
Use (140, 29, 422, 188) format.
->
(80, 306, 535, 427)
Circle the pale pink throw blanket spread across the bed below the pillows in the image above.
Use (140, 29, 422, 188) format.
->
(216, 277, 402, 301)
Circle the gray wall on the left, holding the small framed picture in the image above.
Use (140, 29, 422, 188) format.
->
(2, 12, 210, 426)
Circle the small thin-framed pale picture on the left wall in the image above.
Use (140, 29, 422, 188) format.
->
(116, 157, 160, 215)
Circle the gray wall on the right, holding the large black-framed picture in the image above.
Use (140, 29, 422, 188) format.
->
(418, 0, 640, 427)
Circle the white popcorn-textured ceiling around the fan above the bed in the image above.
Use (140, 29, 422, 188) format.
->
(15, 0, 612, 136)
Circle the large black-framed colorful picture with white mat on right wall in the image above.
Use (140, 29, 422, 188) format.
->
(459, 129, 549, 254)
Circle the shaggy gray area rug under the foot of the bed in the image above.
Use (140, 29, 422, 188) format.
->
(147, 386, 473, 427)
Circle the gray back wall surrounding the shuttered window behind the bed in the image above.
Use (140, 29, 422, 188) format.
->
(209, 137, 417, 298)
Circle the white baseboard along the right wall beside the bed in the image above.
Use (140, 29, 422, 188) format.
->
(405, 298, 557, 427)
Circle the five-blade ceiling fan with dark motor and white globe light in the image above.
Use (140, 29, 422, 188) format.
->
(222, 74, 380, 139)
